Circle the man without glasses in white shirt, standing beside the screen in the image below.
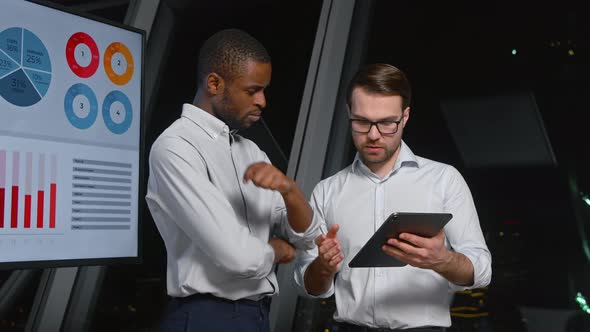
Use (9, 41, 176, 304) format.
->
(146, 29, 317, 332)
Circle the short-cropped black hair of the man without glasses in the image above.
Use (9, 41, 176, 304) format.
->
(197, 29, 270, 85)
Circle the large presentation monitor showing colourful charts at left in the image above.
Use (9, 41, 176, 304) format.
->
(0, 0, 145, 269)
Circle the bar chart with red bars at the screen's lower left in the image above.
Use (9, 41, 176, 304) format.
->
(0, 150, 58, 230)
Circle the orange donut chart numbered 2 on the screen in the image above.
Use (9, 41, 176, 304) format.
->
(103, 42, 134, 85)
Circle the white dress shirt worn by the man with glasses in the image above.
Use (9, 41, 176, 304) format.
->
(295, 142, 492, 328)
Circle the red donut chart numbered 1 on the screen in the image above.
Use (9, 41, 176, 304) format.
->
(66, 32, 100, 78)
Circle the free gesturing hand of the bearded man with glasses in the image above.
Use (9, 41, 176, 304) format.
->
(315, 224, 344, 276)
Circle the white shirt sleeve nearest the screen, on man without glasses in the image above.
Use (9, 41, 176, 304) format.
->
(146, 137, 274, 279)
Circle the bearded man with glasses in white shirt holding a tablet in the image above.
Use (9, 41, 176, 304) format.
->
(295, 64, 492, 332)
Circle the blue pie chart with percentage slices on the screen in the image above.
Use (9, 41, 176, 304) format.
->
(0, 27, 51, 107)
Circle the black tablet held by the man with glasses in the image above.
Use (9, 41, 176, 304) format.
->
(348, 212, 453, 267)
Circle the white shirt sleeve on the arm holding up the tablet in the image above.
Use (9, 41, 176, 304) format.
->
(444, 166, 492, 291)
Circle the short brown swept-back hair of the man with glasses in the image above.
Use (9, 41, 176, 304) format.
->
(346, 63, 412, 110)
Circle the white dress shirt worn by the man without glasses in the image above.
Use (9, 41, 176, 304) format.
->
(146, 104, 317, 300)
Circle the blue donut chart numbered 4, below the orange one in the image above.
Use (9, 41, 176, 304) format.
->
(102, 91, 133, 135)
